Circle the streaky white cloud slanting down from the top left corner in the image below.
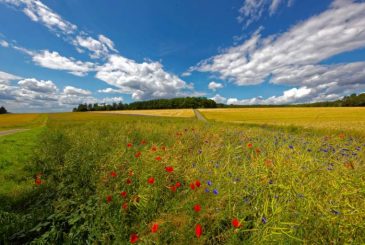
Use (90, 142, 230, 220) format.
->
(0, 0, 77, 34)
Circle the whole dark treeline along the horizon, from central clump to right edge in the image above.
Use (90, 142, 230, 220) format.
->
(72, 93, 365, 112)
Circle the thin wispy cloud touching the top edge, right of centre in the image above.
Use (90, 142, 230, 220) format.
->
(237, 0, 292, 27)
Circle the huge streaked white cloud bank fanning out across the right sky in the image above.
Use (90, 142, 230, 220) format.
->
(188, 0, 365, 103)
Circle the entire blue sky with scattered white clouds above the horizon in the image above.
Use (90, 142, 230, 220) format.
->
(0, 0, 365, 112)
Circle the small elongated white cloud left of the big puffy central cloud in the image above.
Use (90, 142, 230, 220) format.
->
(32, 50, 94, 76)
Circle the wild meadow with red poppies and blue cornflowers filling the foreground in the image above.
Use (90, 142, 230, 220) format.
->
(0, 109, 365, 244)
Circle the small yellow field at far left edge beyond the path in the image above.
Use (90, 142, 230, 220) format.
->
(0, 114, 47, 130)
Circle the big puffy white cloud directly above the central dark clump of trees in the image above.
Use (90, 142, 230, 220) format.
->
(96, 55, 193, 100)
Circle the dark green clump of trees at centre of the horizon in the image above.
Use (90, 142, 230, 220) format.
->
(73, 97, 217, 112)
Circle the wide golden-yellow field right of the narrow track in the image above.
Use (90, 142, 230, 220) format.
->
(199, 107, 365, 132)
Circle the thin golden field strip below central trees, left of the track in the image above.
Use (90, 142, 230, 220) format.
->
(96, 109, 194, 117)
